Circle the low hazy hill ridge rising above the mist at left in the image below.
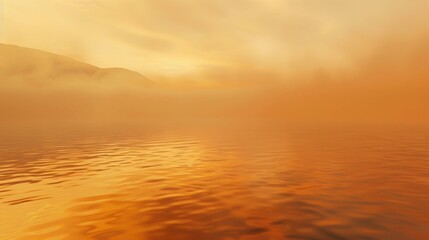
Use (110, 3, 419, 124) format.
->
(0, 44, 153, 86)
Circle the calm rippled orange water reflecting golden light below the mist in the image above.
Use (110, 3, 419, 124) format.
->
(0, 126, 429, 240)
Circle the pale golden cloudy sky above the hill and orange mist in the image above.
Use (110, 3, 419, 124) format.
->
(0, 0, 429, 80)
